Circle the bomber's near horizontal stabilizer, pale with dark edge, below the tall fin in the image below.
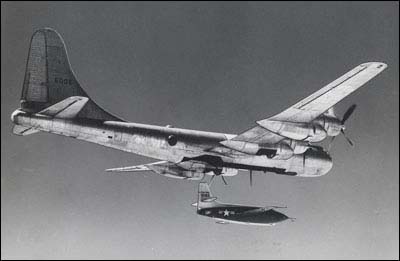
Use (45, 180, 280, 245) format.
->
(38, 96, 89, 119)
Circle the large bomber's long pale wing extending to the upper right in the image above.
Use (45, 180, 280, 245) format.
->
(232, 62, 387, 144)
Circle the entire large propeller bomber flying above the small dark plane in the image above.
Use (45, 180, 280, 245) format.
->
(11, 28, 387, 180)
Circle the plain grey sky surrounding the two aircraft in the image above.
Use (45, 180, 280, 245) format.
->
(1, 2, 399, 259)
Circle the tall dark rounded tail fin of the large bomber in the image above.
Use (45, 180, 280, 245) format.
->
(21, 28, 122, 121)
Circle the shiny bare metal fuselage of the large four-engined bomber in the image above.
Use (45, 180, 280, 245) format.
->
(11, 110, 332, 177)
